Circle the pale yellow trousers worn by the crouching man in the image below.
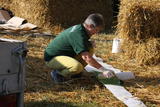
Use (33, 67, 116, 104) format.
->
(46, 49, 93, 77)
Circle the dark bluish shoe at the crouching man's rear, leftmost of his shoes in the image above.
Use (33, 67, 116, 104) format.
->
(51, 70, 65, 84)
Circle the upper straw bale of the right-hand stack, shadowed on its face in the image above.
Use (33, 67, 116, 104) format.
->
(117, 0, 160, 41)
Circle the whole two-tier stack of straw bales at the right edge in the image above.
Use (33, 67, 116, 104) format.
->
(117, 0, 160, 65)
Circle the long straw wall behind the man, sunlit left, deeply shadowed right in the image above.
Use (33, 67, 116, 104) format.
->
(0, 0, 113, 32)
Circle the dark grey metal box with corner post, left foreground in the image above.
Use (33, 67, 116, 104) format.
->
(0, 38, 27, 107)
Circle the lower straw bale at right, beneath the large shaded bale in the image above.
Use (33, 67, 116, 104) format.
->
(122, 38, 160, 65)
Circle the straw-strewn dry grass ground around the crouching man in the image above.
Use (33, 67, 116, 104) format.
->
(0, 35, 160, 107)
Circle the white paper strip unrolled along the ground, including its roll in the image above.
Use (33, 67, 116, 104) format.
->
(85, 55, 146, 107)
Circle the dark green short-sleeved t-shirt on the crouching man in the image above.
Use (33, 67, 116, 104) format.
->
(44, 24, 91, 61)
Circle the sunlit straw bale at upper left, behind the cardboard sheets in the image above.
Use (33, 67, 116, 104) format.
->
(11, 0, 48, 27)
